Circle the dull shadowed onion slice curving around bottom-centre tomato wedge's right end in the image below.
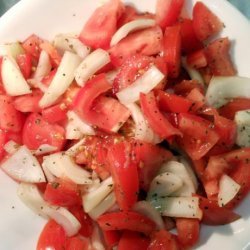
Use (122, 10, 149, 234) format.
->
(133, 201, 165, 230)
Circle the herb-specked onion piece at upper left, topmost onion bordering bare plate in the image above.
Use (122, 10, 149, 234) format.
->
(53, 34, 90, 59)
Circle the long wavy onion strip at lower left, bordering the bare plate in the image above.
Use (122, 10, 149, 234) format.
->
(17, 183, 81, 237)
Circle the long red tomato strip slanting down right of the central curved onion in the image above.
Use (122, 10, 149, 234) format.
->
(140, 92, 181, 139)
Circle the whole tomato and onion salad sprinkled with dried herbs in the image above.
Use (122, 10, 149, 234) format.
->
(0, 0, 250, 250)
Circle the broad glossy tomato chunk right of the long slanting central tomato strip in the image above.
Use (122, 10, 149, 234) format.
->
(178, 113, 219, 160)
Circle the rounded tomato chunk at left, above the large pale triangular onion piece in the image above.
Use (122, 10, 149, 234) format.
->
(23, 113, 65, 151)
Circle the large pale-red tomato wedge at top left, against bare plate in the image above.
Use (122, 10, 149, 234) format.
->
(79, 0, 124, 49)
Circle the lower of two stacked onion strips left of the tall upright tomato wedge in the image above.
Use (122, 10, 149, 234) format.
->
(88, 192, 116, 220)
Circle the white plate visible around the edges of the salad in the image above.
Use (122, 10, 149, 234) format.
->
(0, 0, 250, 250)
